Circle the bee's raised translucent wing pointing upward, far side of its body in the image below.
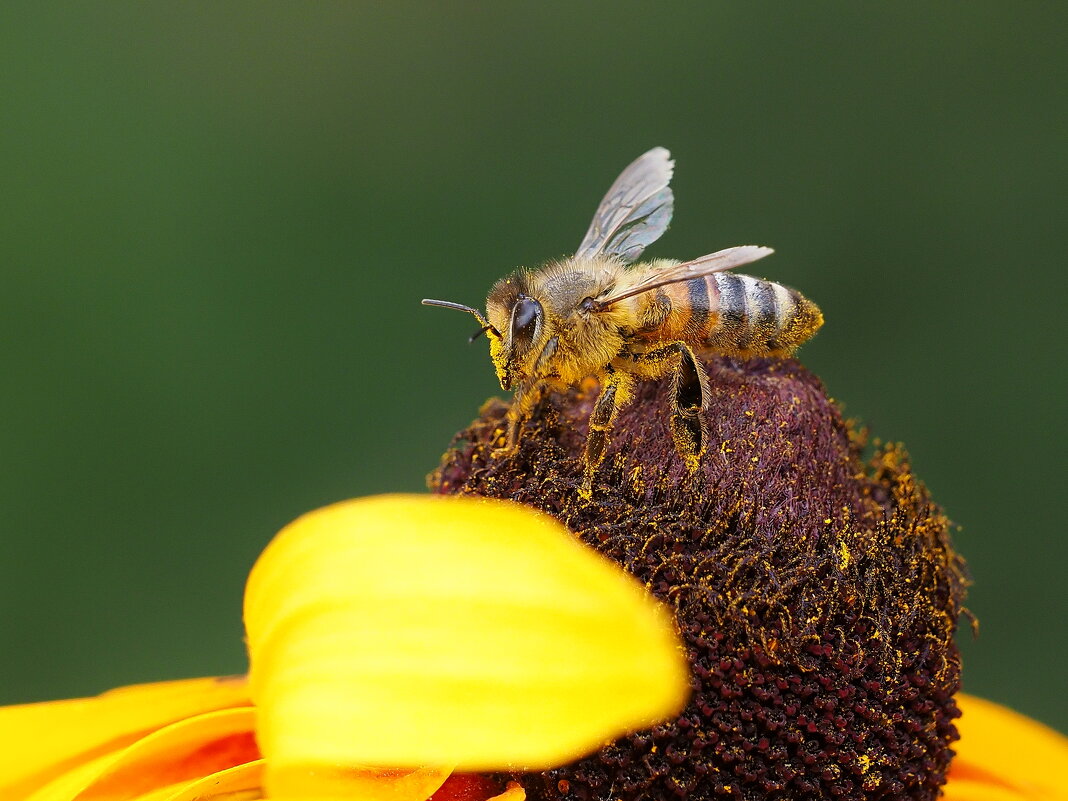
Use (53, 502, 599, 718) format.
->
(575, 147, 675, 264)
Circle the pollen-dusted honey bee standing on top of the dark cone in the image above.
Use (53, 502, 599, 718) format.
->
(423, 147, 823, 497)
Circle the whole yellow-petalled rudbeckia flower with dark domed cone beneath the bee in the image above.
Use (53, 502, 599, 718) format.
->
(0, 360, 1068, 801)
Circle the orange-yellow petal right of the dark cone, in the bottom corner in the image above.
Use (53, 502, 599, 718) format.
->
(944, 694, 1068, 801)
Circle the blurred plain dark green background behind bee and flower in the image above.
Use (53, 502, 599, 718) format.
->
(0, 2, 1068, 729)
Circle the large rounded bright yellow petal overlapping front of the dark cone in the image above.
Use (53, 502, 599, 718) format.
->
(245, 496, 688, 786)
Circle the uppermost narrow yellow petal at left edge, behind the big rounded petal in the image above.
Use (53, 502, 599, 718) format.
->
(0, 677, 249, 799)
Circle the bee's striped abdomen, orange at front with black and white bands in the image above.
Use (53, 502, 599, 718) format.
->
(638, 272, 823, 356)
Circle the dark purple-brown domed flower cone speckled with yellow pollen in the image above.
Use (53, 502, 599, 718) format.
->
(429, 359, 965, 801)
